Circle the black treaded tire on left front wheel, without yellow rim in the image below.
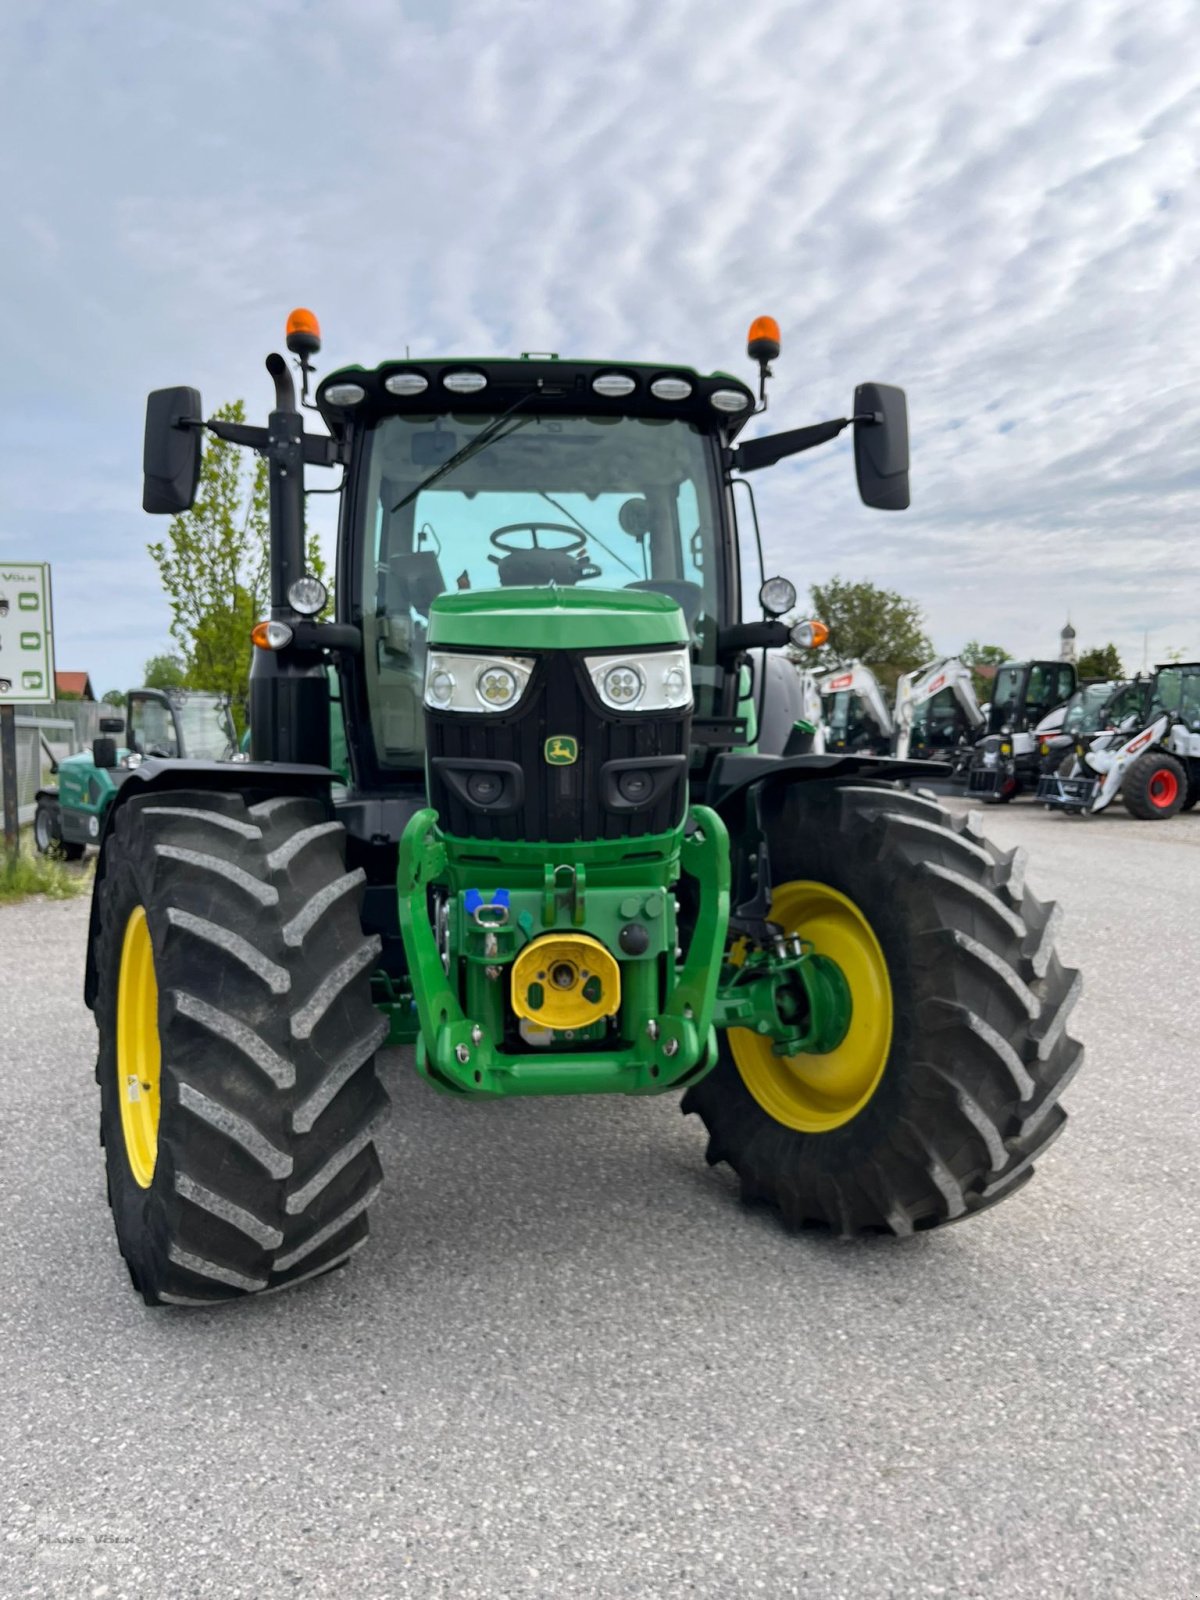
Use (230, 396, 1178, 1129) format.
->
(96, 792, 395, 1306)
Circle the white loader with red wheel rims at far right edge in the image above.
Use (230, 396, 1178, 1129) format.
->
(1037, 661, 1200, 821)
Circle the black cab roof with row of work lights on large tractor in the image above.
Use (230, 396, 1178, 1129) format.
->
(317, 354, 754, 438)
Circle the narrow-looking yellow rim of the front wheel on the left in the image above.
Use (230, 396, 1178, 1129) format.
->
(117, 906, 162, 1189)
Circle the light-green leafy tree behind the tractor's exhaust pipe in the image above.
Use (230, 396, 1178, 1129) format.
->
(147, 400, 325, 733)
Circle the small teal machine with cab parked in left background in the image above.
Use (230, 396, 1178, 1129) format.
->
(34, 690, 237, 861)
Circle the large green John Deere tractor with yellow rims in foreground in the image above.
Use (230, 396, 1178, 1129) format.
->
(86, 312, 1080, 1306)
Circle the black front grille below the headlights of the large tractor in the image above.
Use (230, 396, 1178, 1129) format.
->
(426, 653, 691, 843)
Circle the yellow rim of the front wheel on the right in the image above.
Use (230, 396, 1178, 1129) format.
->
(730, 880, 891, 1133)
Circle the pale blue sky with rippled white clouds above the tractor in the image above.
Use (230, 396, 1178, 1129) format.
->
(0, 0, 1200, 691)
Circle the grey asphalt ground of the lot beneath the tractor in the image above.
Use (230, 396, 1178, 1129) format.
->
(0, 800, 1200, 1600)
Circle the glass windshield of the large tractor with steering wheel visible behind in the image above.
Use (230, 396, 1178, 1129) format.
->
(358, 411, 725, 766)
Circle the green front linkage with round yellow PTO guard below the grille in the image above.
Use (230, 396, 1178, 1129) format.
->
(397, 806, 730, 1098)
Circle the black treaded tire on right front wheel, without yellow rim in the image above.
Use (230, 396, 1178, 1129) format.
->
(683, 784, 1083, 1237)
